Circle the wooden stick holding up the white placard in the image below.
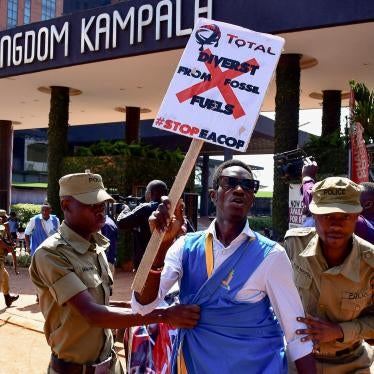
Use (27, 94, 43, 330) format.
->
(131, 139, 204, 293)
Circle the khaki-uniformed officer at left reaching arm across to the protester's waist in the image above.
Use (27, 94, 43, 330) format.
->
(30, 173, 199, 374)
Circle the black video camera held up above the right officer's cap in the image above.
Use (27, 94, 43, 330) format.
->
(274, 148, 314, 181)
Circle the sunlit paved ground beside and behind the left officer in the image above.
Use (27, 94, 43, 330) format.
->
(0, 267, 133, 374)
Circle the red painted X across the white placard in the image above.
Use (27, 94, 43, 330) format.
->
(177, 48, 258, 119)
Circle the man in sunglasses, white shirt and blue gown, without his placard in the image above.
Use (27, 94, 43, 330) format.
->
(132, 160, 314, 374)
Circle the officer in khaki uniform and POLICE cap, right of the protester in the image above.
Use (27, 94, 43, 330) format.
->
(284, 177, 374, 374)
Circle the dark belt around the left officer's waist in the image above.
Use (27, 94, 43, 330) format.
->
(50, 354, 114, 374)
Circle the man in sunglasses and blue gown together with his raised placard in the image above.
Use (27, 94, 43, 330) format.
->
(132, 19, 315, 374)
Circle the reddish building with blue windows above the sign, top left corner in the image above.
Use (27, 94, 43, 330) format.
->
(0, 0, 63, 31)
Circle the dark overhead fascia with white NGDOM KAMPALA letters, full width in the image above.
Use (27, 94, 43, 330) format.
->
(0, 0, 374, 78)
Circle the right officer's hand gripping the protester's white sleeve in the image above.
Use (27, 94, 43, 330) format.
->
(296, 316, 344, 351)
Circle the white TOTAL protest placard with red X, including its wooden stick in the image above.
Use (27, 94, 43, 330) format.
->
(132, 18, 284, 292)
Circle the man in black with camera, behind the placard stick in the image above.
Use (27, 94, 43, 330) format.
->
(117, 179, 168, 270)
